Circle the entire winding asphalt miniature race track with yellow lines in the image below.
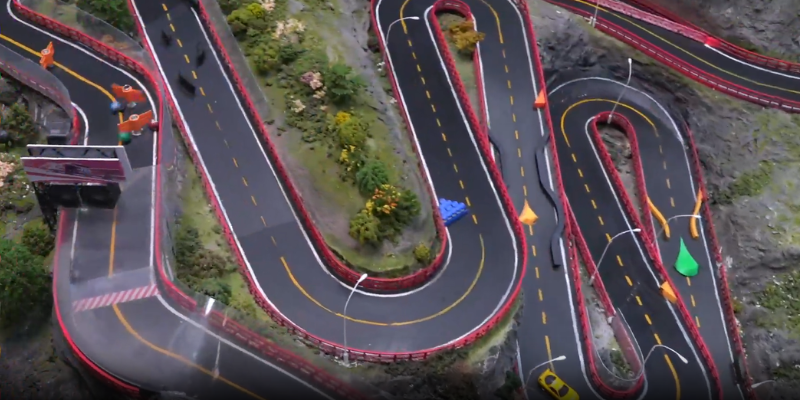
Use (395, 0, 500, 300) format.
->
(6, 0, 800, 400)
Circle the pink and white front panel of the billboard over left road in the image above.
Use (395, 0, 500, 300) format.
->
(20, 157, 126, 185)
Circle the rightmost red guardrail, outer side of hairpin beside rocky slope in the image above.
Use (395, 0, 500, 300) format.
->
(685, 125, 758, 400)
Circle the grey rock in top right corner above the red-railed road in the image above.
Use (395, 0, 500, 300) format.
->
(649, 0, 800, 60)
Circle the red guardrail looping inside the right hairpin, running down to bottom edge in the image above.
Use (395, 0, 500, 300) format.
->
(592, 107, 722, 398)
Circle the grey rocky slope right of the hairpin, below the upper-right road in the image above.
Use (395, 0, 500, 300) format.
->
(529, 0, 800, 390)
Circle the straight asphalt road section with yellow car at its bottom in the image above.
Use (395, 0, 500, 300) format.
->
(465, 0, 596, 398)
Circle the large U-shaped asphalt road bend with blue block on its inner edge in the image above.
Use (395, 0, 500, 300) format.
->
(134, 0, 522, 352)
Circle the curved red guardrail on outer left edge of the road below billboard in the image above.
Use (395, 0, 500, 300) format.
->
(53, 212, 139, 398)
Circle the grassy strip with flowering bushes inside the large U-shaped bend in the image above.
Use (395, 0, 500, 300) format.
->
(223, 0, 438, 277)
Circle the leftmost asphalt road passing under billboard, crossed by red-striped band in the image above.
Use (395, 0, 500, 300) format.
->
(0, 3, 335, 400)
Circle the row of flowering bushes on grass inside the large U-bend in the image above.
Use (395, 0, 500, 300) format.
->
(220, 0, 421, 247)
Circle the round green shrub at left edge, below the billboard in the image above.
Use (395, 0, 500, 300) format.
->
(0, 239, 52, 326)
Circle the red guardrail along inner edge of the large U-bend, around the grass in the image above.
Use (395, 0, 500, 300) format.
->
(198, 2, 447, 296)
